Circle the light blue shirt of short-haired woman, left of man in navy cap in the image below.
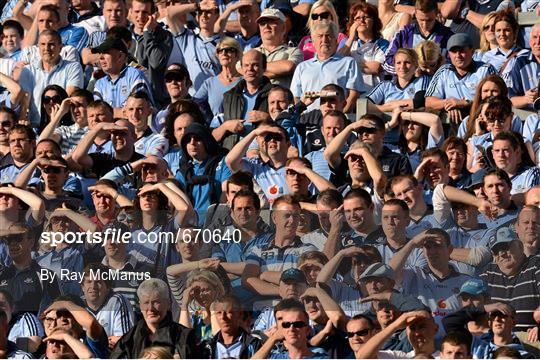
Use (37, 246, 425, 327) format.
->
(367, 75, 429, 105)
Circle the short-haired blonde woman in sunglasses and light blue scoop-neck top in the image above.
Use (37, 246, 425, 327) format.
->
(194, 37, 242, 115)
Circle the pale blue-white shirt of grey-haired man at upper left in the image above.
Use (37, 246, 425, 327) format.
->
(19, 59, 84, 125)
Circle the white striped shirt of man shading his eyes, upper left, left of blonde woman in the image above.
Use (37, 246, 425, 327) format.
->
(174, 28, 221, 94)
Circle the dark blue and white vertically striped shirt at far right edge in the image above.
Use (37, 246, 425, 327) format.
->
(508, 53, 540, 97)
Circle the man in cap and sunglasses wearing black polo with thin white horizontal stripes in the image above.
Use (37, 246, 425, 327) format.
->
(480, 227, 540, 331)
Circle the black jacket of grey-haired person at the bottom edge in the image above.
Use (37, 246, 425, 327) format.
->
(110, 312, 200, 359)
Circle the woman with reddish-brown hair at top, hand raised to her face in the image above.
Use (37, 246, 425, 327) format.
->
(339, 2, 389, 91)
